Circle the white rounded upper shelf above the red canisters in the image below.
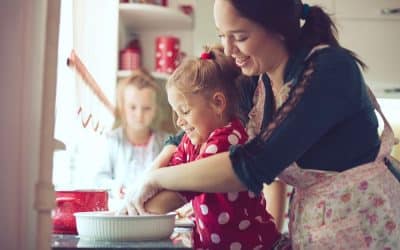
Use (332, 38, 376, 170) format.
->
(119, 3, 193, 31)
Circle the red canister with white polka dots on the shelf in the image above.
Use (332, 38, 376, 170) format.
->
(155, 36, 180, 74)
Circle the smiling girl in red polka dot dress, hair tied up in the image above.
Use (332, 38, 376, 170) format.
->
(146, 48, 280, 249)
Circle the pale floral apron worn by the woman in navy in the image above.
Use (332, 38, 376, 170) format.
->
(279, 86, 400, 250)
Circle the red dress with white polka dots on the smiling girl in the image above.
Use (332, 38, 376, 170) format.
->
(170, 120, 280, 250)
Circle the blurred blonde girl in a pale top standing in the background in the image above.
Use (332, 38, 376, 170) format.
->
(95, 70, 167, 198)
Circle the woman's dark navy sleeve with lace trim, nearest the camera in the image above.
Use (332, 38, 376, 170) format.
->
(230, 48, 363, 193)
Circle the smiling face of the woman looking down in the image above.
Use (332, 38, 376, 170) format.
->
(214, 0, 286, 76)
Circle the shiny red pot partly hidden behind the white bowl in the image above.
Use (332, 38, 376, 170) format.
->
(52, 189, 108, 234)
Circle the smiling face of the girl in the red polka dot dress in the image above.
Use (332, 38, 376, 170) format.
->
(167, 86, 221, 145)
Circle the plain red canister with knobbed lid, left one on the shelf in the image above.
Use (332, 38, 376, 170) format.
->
(119, 39, 142, 70)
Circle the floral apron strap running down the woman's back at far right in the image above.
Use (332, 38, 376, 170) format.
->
(365, 84, 398, 161)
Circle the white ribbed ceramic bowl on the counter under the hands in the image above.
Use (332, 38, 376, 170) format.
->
(74, 211, 175, 241)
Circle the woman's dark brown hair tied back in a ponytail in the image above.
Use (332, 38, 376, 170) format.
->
(229, 0, 366, 68)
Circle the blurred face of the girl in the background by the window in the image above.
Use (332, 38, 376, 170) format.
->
(123, 86, 157, 131)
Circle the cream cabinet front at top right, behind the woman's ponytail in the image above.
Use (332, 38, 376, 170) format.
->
(335, 0, 400, 86)
